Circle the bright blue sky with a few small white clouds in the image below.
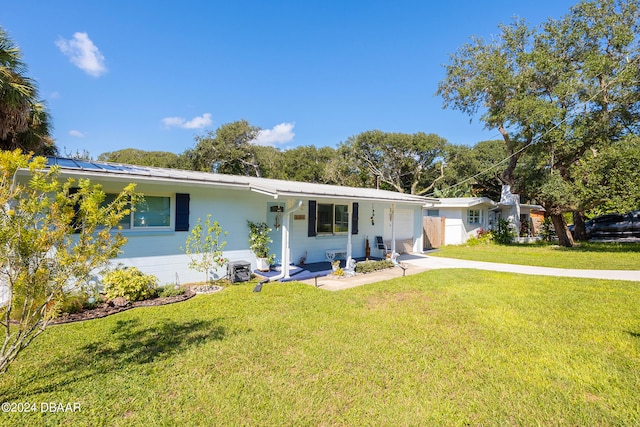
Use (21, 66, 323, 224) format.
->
(0, 0, 576, 157)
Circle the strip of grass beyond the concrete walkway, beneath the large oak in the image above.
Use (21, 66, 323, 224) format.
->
(429, 243, 640, 270)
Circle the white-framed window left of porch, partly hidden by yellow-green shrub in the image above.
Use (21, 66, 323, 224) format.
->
(103, 194, 172, 230)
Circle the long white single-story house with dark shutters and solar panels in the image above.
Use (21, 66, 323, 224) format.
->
(18, 157, 435, 283)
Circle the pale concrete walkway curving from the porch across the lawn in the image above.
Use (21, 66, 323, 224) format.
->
(303, 254, 640, 291)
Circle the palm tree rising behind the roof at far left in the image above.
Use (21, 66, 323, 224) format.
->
(0, 27, 57, 154)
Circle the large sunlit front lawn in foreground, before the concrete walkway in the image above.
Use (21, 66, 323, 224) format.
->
(0, 270, 640, 426)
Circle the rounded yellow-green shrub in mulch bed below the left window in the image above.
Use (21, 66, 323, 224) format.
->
(102, 267, 158, 302)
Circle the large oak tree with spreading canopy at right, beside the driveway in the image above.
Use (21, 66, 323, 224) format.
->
(438, 0, 640, 246)
